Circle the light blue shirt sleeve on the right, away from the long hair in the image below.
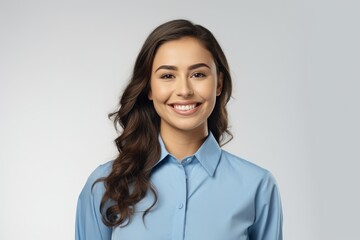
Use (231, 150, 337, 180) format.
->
(249, 172, 283, 240)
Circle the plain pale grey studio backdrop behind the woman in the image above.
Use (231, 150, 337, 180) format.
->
(0, 0, 360, 240)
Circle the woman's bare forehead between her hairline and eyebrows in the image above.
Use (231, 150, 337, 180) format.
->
(153, 37, 214, 68)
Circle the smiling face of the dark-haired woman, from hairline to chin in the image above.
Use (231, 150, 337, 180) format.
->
(149, 37, 222, 133)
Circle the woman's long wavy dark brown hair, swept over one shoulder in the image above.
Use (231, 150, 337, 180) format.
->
(98, 20, 232, 227)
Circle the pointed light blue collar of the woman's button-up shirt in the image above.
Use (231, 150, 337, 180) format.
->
(155, 132, 221, 176)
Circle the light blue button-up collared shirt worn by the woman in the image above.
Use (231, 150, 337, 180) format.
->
(76, 133, 282, 240)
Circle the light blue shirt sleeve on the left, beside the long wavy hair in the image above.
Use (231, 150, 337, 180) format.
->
(75, 166, 112, 240)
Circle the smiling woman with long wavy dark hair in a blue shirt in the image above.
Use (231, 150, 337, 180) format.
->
(76, 20, 282, 240)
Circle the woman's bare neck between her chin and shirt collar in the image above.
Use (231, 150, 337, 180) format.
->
(160, 125, 208, 161)
